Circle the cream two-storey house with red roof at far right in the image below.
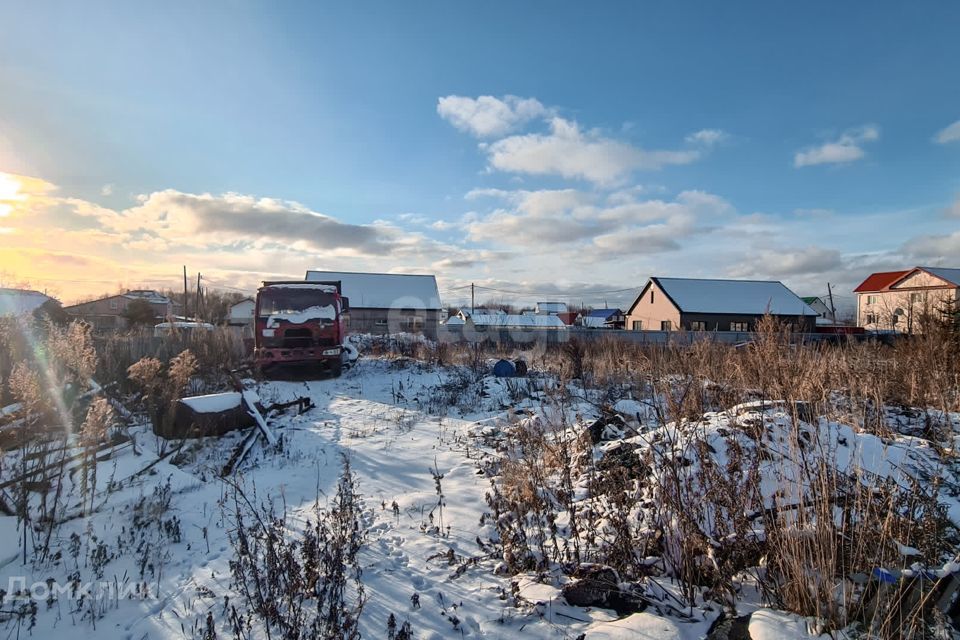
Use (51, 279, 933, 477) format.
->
(853, 267, 960, 333)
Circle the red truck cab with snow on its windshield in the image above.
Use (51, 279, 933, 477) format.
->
(253, 280, 348, 376)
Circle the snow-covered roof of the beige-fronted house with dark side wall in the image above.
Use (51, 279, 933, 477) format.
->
(634, 277, 819, 316)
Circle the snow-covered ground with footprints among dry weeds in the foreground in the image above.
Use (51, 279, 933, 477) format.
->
(0, 358, 960, 640)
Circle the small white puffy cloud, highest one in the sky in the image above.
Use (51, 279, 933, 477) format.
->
(437, 96, 550, 138)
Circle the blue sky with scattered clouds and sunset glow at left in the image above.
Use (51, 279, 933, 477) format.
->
(0, 0, 960, 306)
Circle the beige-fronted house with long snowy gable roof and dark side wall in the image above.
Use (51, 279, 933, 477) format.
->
(626, 277, 817, 332)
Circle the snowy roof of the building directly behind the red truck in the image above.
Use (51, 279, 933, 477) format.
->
(306, 270, 441, 310)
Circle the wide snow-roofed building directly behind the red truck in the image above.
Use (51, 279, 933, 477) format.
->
(306, 270, 446, 337)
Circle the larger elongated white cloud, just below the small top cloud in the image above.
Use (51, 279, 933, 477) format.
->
(482, 117, 700, 184)
